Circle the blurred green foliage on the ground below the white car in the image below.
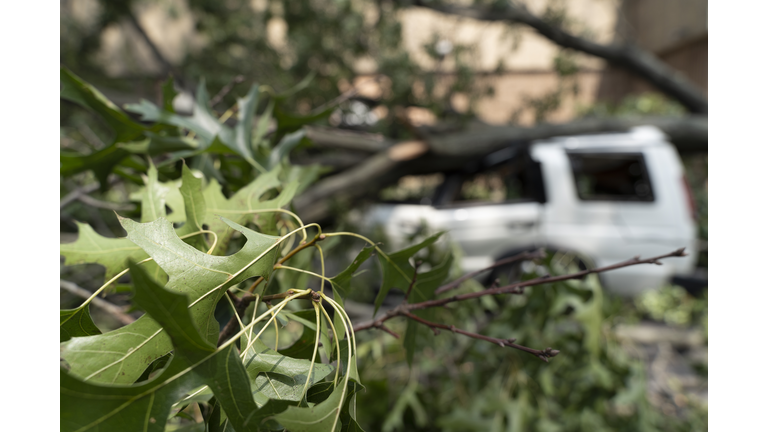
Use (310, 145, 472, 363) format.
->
(348, 248, 706, 431)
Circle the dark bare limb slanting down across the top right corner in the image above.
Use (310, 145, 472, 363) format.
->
(413, 0, 708, 114)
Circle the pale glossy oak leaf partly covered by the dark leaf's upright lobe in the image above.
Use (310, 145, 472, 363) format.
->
(61, 218, 279, 384)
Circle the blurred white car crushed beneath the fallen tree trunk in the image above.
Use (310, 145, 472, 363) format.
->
(365, 127, 697, 296)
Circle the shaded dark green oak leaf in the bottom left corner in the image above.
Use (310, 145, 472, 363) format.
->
(59, 263, 287, 432)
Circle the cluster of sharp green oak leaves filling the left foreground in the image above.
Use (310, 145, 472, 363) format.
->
(60, 69, 516, 431)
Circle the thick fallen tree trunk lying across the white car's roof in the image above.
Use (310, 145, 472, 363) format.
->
(294, 115, 707, 222)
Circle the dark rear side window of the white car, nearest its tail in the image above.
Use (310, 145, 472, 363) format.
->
(568, 152, 654, 202)
